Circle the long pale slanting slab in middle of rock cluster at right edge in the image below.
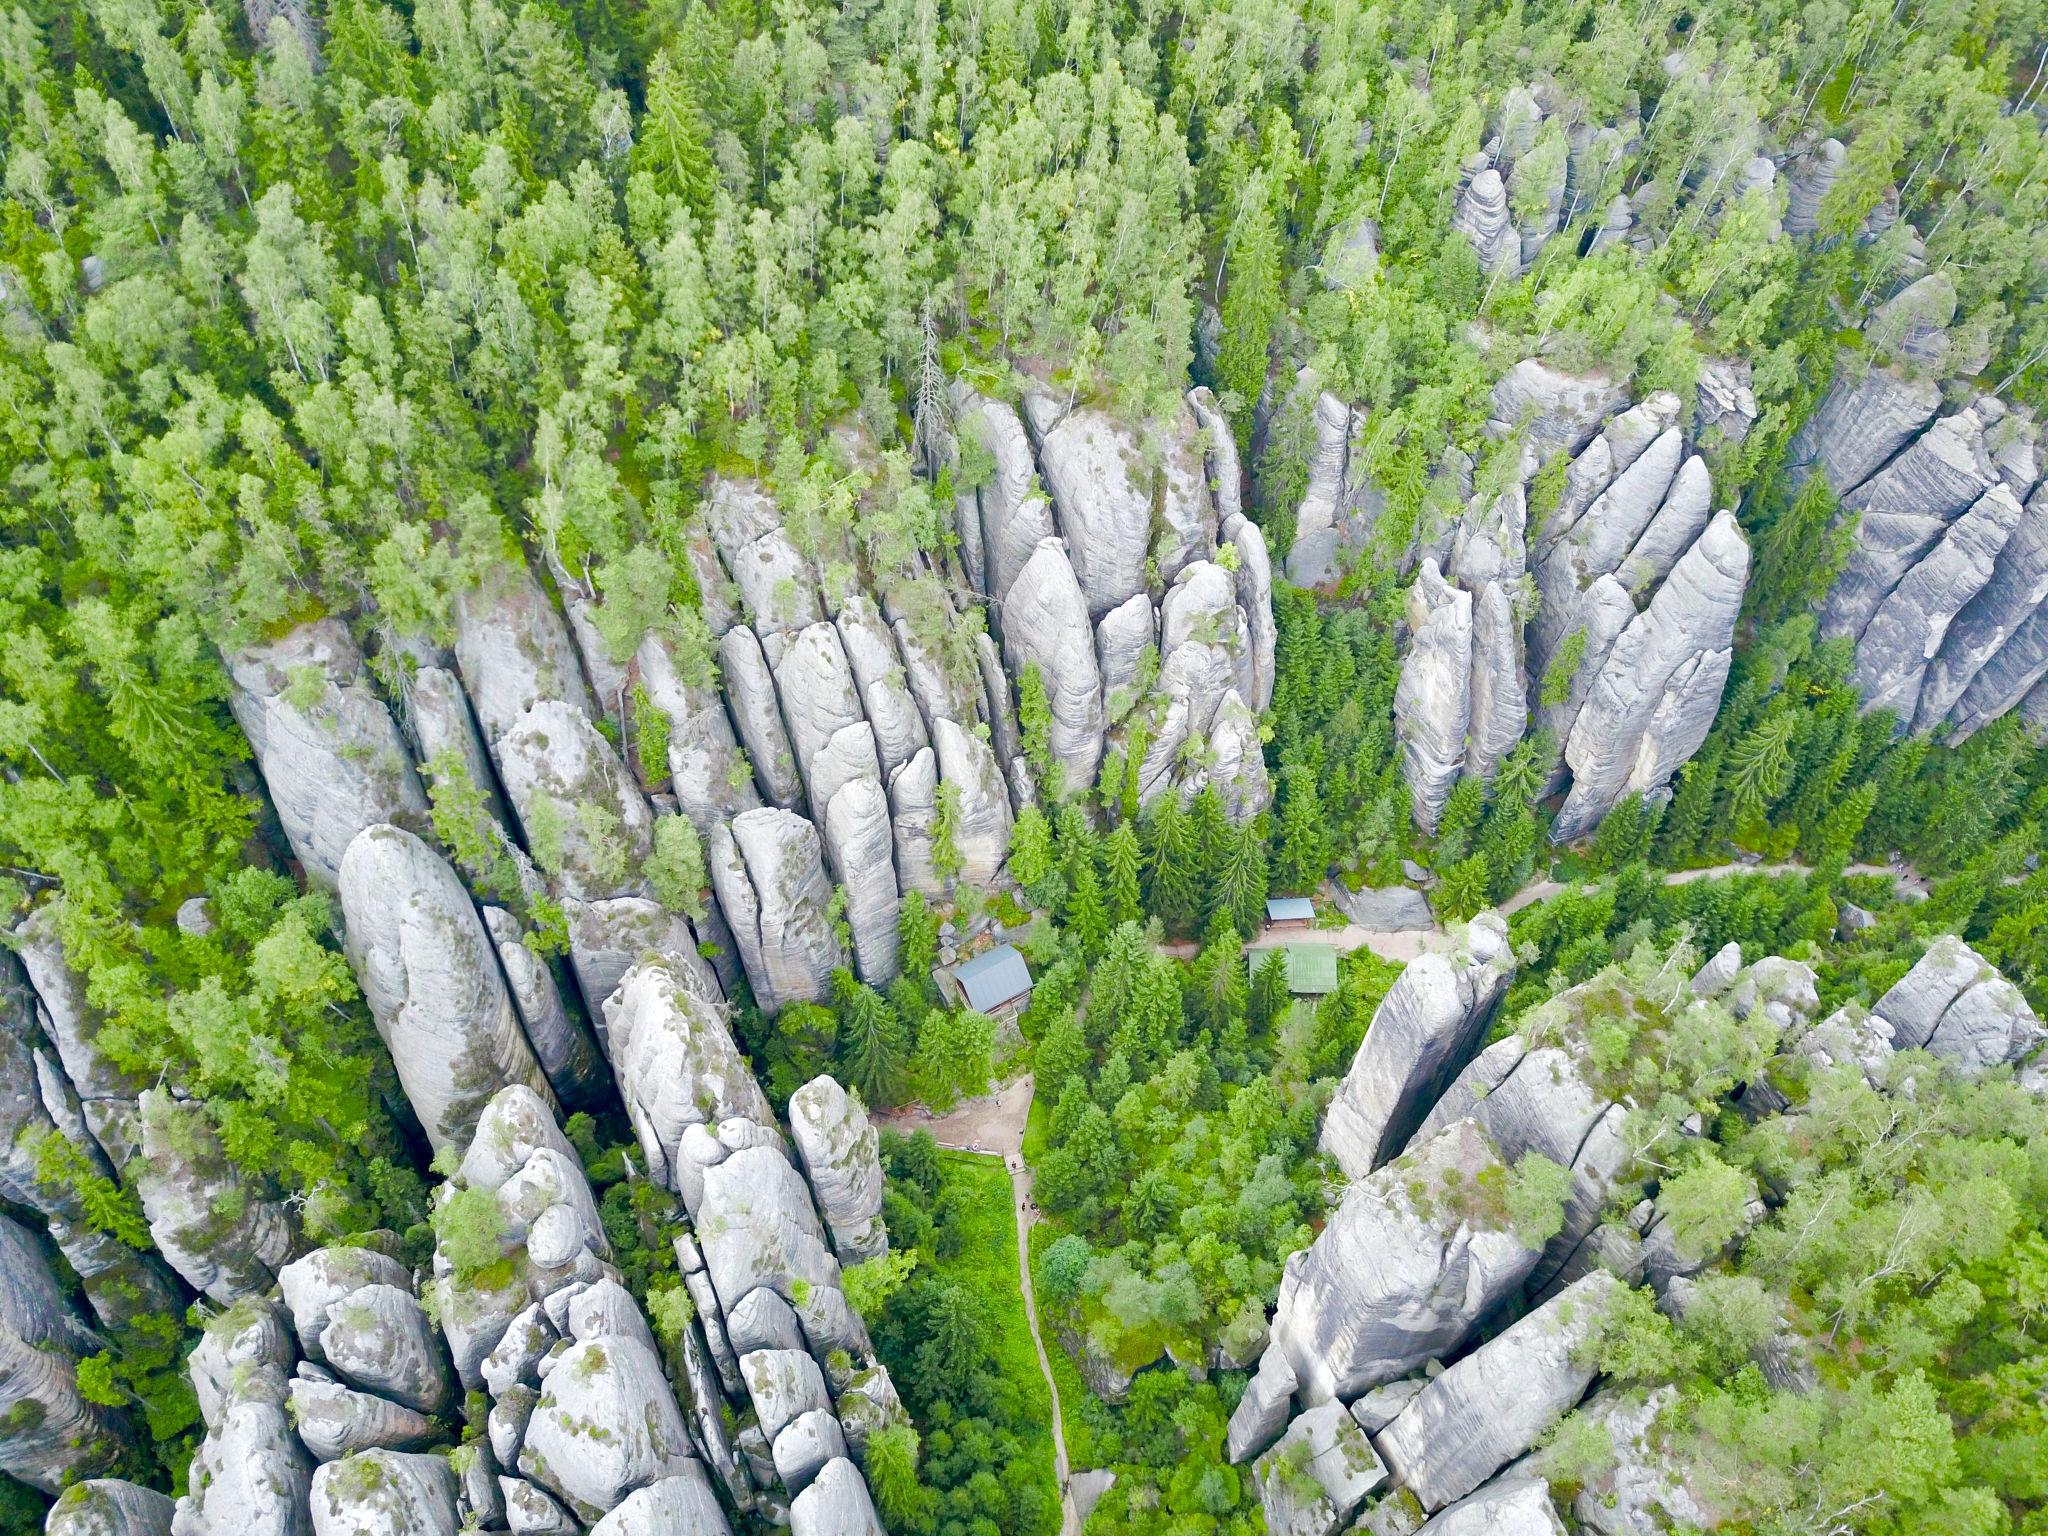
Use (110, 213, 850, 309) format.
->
(1853, 485, 2021, 723)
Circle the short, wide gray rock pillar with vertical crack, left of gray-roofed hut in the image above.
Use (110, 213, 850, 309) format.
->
(705, 807, 846, 1012)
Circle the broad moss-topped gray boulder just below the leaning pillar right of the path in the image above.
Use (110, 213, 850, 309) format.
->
(1272, 1120, 1538, 1403)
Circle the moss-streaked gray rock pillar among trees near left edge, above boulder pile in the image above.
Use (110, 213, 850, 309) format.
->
(135, 1087, 295, 1303)
